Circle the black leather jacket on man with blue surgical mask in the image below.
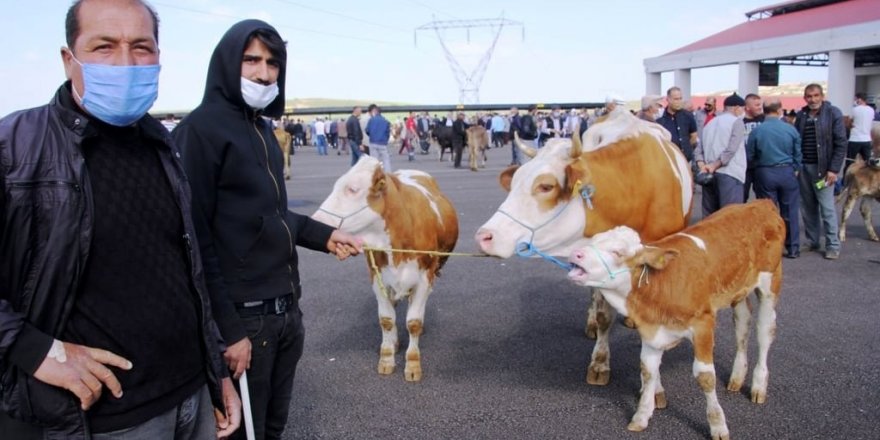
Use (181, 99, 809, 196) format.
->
(0, 84, 228, 439)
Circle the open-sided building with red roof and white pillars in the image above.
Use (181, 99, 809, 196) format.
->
(644, 0, 880, 113)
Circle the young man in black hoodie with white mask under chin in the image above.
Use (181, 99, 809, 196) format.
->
(173, 20, 361, 439)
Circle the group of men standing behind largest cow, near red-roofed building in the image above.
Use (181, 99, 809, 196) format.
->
(639, 84, 880, 260)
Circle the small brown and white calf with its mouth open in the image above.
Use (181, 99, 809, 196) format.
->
(568, 200, 785, 439)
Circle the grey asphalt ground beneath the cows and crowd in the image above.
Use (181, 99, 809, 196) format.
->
(285, 142, 880, 440)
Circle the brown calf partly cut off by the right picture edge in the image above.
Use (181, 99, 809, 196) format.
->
(838, 122, 880, 241)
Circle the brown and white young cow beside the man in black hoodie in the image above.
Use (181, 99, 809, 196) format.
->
(312, 156, 458, 381)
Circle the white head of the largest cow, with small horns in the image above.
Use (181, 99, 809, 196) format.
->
(475, 134, 586, 258)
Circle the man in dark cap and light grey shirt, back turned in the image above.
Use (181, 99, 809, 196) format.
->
(694, 93, 746, 217)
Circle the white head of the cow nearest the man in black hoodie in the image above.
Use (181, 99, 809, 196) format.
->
(312, 155, 385, 235)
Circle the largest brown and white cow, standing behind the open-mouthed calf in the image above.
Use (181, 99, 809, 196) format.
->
(475, 111, 693, 385)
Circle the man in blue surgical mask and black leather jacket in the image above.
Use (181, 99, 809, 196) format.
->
(0, 0, 241, 439)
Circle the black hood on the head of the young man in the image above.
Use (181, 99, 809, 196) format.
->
(202, 19, 287, 118)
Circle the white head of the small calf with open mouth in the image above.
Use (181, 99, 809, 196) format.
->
(568, 226, 643, 292)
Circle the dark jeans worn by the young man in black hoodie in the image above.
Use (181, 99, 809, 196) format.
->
(230, 304, 305, 440)
